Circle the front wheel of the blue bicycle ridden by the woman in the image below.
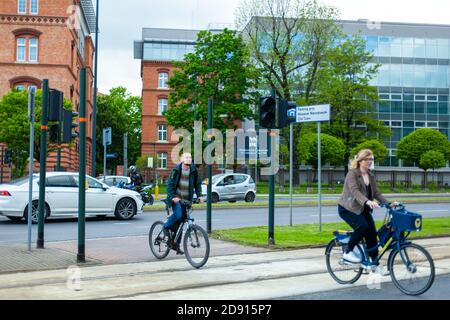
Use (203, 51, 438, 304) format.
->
(389, 243, 435, 296)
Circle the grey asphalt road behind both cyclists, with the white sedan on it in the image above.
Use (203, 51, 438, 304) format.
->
(0, 203, 450, 244)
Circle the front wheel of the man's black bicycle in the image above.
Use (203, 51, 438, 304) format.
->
(183, 225, 209, 269)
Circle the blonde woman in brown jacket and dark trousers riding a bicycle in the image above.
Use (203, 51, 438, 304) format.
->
(338, 149, 398, 275)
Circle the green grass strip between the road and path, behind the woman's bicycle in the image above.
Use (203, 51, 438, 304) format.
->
(211, 217, 450, 249)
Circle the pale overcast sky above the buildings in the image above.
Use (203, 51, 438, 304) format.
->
(93, 0, 450, 96)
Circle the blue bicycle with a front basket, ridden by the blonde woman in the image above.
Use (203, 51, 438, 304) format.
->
(325, 204, 435, 295)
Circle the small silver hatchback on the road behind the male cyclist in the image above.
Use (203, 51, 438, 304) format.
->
(202, 173, 256, 202)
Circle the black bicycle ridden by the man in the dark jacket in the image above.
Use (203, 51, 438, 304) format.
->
(148, 199, 210, 269)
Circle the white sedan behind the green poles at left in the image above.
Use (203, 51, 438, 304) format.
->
(0, 172, 144, 223)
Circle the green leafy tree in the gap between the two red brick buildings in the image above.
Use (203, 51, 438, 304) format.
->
(96, 87, 142, 172)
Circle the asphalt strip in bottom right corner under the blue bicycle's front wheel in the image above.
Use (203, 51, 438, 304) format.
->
(280, 274, 450, 301)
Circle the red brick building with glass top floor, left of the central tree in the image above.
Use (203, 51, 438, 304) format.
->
(134, 28, 199, 177)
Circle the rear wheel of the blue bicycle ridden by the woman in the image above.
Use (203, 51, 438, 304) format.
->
(325, 239, 363, 284)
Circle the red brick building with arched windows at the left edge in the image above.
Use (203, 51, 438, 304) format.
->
(0, 0, 95, 182)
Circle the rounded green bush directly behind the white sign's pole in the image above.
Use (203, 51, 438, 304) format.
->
(297, 133, 345, 168)
